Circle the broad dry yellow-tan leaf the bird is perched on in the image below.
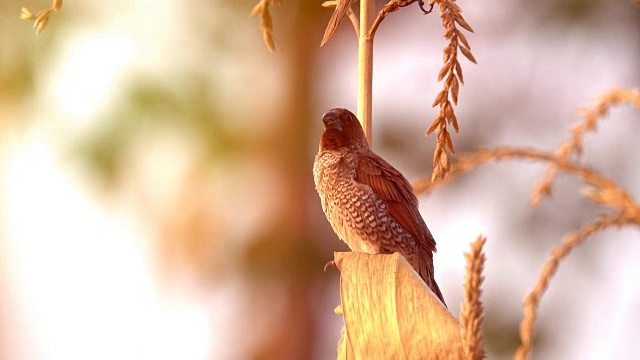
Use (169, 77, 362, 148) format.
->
(335, 252, 464, 359)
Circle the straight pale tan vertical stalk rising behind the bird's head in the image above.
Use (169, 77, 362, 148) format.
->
(358, 0, 375, 146)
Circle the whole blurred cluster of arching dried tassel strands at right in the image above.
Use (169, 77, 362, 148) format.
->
(414, 89, 640, 360)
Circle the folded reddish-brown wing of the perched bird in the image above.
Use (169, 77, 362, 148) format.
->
(355, 153, 435, 251)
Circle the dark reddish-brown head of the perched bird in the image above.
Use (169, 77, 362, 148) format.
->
(320, 108, 369, 151)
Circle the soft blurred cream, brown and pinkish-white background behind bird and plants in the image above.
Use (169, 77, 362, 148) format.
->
(0, 0, 640, 360)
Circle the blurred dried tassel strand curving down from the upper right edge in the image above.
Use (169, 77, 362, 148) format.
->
(531, 88, 640, 206)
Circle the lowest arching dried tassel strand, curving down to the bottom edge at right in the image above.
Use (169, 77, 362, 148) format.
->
(515, 213, 638, 360)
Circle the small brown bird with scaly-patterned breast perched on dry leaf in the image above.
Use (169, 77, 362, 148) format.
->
(313, 108, 446, 306)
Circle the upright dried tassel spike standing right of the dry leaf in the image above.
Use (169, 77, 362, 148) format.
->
(460, 236, 487, 360)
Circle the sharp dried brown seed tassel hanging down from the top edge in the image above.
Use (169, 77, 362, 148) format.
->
(427, 0, 476, 180)
